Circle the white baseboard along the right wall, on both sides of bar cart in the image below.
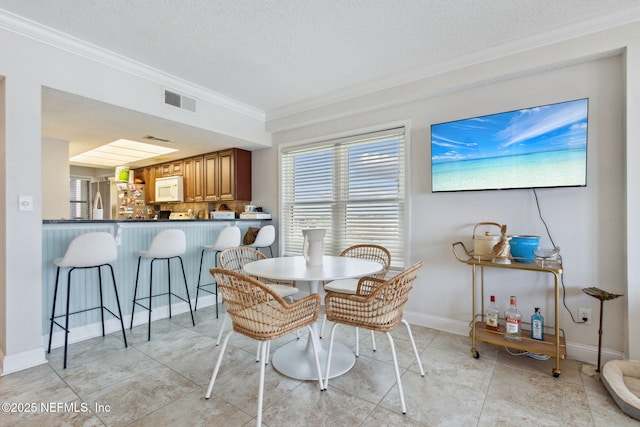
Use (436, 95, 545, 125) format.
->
(404, 311, 626, 366)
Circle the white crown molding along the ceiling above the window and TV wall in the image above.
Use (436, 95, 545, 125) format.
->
(267, 5, 640, 122)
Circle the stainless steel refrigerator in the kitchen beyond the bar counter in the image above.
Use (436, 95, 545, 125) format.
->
(89, 179, 148, 220)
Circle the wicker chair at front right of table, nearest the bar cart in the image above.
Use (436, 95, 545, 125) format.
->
(324, 261, 424, 414)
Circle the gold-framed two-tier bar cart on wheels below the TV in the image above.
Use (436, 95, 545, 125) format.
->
(452, 242, 567, 378)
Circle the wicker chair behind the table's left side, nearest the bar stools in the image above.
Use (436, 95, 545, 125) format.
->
(216, 246, 298, 350)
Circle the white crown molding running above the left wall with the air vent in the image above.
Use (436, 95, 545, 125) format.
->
(0, 9, 265, 122)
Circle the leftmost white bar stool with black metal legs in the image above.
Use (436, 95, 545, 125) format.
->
(47, 232, 127, 369)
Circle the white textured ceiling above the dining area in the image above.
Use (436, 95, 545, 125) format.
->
(0, 0, 638, 115)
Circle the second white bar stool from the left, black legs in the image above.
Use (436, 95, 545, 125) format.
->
(129, 230, 196, 341)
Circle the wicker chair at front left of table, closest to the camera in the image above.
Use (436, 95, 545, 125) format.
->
(205, 268, 323, 427)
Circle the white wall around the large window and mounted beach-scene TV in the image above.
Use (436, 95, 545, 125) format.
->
(253, 25, 640, 362)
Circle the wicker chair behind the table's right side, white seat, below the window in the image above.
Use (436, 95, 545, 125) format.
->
(320, 244, 391, 356)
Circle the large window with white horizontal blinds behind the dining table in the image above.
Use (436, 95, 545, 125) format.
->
(280, 128, 405, 268)
